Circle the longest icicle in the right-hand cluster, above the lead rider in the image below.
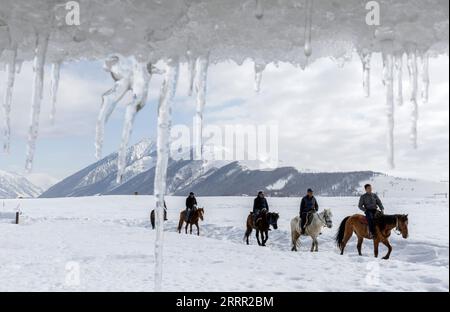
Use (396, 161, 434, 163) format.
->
(383, 52, 395, 169)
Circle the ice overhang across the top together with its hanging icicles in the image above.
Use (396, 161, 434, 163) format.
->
(0, 0, 449, 174)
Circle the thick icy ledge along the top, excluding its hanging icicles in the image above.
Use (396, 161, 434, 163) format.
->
(0, 0, 449, 66)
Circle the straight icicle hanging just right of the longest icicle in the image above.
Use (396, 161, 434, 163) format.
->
(194, 54, 209, 159)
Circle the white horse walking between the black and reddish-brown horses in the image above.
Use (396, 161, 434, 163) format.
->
(291, 209, 333, 252)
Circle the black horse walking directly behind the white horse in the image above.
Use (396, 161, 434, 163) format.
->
(244, 209, 280, 246)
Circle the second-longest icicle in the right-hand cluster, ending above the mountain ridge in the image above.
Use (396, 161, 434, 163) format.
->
(408, 48, 419, 149)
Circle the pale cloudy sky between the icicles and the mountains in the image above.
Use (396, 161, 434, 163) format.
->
(0, 52, 449, 187)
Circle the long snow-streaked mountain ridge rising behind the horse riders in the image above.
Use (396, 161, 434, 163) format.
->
(41, 140, 448, 198)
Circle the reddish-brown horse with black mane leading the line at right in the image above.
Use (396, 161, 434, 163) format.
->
(336, 214, 408, 260)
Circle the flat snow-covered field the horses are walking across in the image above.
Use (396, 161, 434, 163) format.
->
(0, 196, 449, 292)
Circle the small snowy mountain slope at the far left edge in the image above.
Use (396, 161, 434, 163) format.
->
(0, 170, 42, 199)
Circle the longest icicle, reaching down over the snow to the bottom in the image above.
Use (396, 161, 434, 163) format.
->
(154, 58, 180, 291)
